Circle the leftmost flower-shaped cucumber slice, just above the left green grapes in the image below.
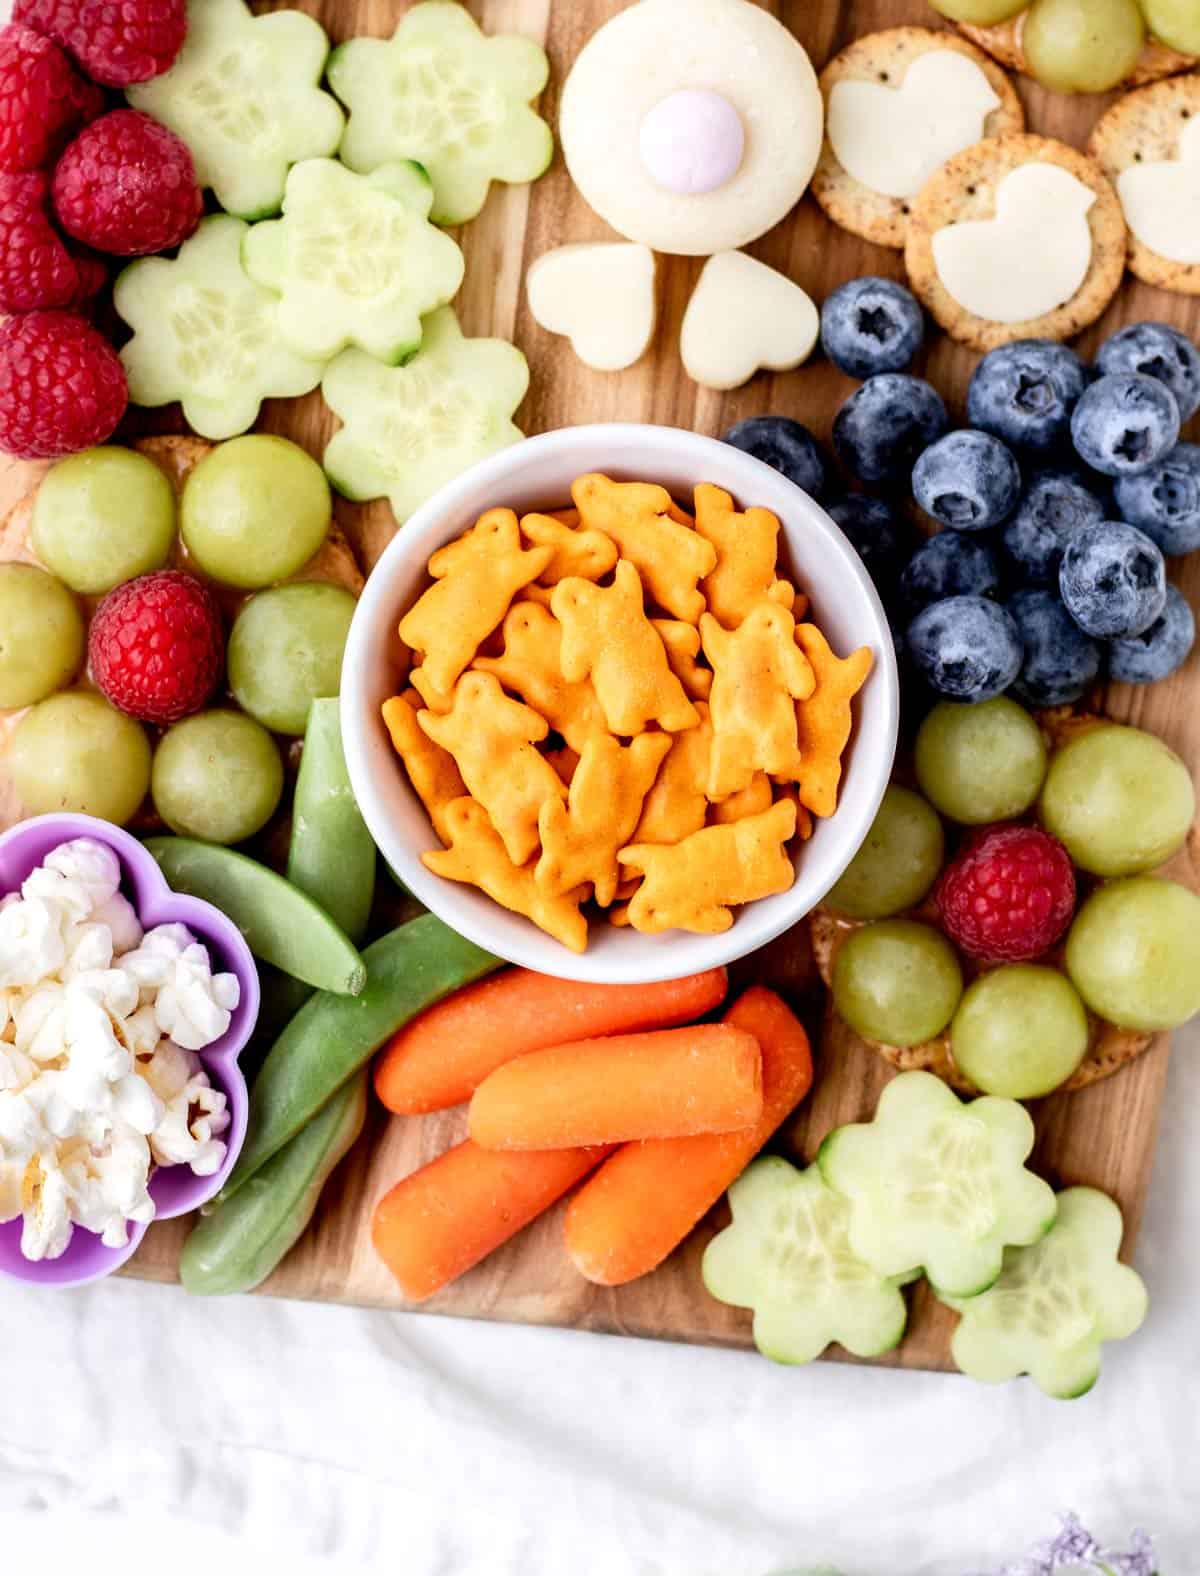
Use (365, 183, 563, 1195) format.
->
(112, 214, 325, 441)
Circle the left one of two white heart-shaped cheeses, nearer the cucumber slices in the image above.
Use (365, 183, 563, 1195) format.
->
(525, 241, 658, 372)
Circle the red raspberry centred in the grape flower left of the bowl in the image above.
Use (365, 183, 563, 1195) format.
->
(88, 569, 225, 723)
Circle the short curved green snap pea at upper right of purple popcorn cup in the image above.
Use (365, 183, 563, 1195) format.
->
(145, 837, 366, 996)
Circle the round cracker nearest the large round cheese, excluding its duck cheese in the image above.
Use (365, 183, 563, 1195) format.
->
(812, 27, 1025, 251)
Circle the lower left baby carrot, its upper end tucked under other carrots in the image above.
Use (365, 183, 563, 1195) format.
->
(371, 1139, 610, 1302)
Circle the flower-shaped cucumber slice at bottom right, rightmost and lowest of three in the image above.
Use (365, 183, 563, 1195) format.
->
(949, 1187, 1148, 1401)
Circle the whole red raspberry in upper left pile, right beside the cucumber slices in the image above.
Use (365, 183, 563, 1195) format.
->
(54, 109, 203, 257)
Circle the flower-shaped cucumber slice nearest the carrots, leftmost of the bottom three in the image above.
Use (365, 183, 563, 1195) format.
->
(702, 1155, 908, 1363)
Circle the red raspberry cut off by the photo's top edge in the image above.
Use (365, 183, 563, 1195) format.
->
(13, 0, 188, 88)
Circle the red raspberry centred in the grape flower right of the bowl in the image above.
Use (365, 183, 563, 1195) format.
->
(935, 826, 1075, 963)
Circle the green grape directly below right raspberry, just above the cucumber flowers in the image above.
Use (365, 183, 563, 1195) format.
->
(949, 963, 1088, 1100)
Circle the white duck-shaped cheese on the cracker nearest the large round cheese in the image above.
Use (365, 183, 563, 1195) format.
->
(826, 49, 1000, 197)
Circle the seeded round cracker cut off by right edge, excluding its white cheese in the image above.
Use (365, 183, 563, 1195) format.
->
(1088, 71, 1200, 295)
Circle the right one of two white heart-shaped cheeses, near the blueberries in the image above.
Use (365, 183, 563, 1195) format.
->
(680, 252, 820, 389)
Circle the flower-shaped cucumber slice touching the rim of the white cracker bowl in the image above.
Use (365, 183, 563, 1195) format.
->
(322, 306, 530, 525)
